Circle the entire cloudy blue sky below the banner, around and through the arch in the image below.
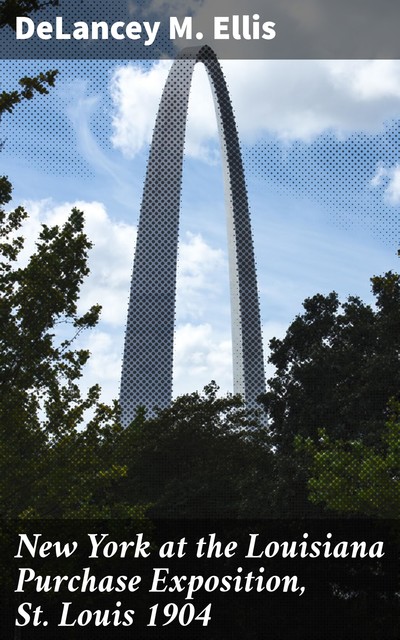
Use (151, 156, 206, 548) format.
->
(1, 61, 400, 400)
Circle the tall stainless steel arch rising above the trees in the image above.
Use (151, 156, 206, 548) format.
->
(120, 46, 265, 425)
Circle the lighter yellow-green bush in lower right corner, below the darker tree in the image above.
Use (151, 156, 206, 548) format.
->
(296, 402, 400, 519)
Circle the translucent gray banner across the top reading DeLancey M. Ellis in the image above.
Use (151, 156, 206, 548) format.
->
(0, 0, 400, 59)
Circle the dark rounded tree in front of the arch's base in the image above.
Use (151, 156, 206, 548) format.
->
(117, 382, 272, 518)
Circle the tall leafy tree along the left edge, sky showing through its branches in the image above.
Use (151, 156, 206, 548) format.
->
(0, 178, 140, 517)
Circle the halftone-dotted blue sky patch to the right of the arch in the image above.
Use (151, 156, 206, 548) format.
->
(246, 121, 400, 248)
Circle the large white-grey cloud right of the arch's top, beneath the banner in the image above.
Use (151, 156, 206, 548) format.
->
(223, 60, 400, 142)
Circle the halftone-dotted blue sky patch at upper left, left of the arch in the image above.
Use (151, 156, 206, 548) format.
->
(1, 60, 126, 178)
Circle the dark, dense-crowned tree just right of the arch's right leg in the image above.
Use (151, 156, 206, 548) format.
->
(263, 272, 400, 515)
